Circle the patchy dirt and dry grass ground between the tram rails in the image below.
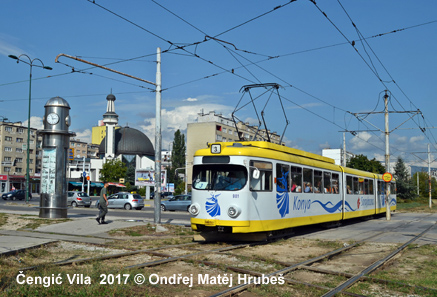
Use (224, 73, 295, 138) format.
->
(0, 215, 437, 297)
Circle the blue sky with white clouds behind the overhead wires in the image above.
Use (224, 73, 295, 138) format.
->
(0, 0, 437, 163)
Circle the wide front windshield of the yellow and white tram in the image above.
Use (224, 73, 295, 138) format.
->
(193, 165, 247, 191)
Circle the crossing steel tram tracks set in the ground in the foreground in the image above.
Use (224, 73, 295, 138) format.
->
(4, 214, 436, 296)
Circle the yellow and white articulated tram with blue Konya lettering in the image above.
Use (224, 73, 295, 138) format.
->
(189, 141, 396, 233)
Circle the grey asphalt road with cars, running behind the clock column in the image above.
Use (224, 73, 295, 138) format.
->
(0, 197, 190, 224)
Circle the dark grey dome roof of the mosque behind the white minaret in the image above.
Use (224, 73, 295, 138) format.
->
(99, 127, 155, 157)
